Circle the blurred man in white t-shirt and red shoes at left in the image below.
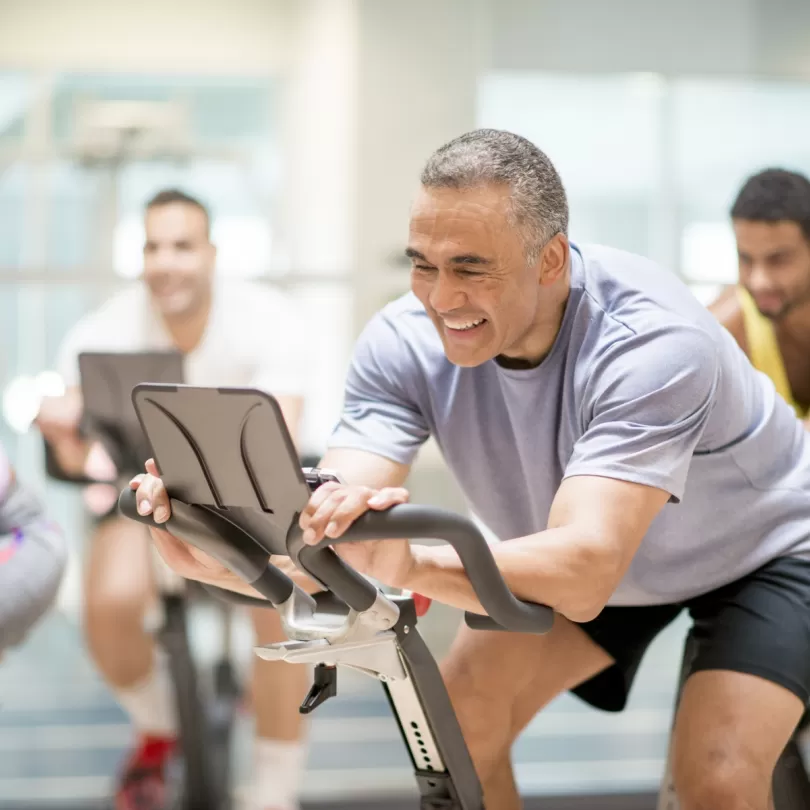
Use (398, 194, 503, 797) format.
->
(37, 190, 308, 810)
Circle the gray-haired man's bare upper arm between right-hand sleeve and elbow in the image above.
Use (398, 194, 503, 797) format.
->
(548, 475, 670, 571)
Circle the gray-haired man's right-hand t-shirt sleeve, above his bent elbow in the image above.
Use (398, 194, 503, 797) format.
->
(564, 325, 719, 503)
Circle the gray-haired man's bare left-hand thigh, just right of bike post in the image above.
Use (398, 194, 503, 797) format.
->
(442, 616, 613, 756)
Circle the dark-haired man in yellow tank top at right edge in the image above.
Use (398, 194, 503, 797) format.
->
(710, 169, 810, 429)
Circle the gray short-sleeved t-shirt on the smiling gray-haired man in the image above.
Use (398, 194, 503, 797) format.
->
(330, 245, 810, 605)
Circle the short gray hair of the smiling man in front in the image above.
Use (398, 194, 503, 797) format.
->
(421, 129, 568, 262)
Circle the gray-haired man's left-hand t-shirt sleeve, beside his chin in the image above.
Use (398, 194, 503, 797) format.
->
(328, 313, 430, 464)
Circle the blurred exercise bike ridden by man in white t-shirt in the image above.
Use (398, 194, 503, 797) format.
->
(46, 352, 241, 810)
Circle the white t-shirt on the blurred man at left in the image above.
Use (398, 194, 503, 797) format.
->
(56, 281, 306, 396)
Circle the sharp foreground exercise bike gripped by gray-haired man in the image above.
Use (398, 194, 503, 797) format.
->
(119, 385, 553, 810)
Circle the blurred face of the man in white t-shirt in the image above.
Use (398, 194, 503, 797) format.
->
(143, 202, 216, 317)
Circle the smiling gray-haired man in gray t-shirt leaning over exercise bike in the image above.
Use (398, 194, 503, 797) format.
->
(133, 130, 810, 810)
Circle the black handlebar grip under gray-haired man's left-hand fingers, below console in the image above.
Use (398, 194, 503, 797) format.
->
(118, 488, 295, 605)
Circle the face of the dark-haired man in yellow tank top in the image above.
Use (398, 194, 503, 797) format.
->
(734, 219, 810, 320)
